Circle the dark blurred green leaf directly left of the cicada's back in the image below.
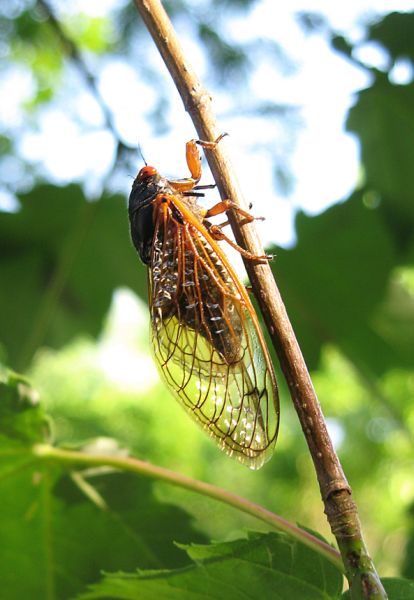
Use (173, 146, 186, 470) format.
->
(0, 185, 147, 368)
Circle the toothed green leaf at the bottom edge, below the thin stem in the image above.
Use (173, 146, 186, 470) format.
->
(79, 533, 342, 600)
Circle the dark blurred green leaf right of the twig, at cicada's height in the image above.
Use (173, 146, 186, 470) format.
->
(272, 192, 404, 373)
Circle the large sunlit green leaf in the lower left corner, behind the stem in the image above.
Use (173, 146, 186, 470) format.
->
(0, 374, 205, 600)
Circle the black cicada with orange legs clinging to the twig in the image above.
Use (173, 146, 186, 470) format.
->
(128, 136, 279, 469)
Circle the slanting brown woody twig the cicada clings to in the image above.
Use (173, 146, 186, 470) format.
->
(134, 0, 387, 599)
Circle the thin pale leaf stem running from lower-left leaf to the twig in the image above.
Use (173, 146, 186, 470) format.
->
(33, 444, 343, 571)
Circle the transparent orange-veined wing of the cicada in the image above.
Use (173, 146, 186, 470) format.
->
(150, 202, 279, 469)
